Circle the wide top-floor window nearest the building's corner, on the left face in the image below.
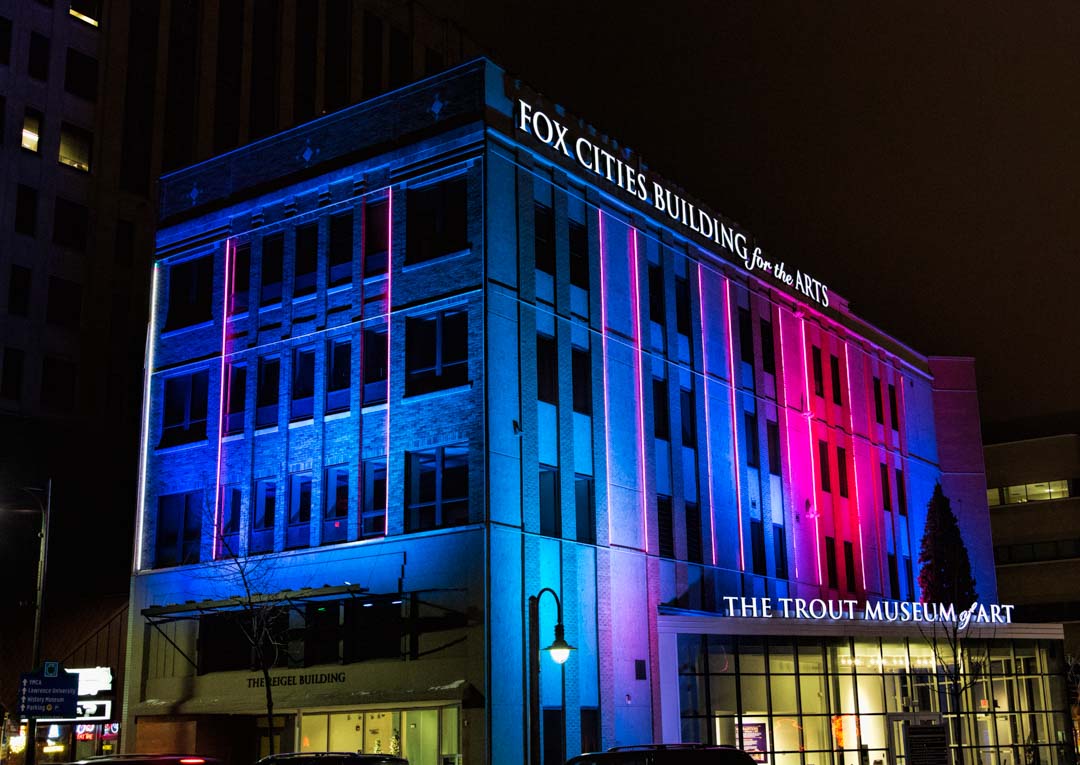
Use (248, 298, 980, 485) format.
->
(405, 175, 469, 264)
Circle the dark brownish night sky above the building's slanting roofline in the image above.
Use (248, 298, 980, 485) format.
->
(440, 0, 1080, 440)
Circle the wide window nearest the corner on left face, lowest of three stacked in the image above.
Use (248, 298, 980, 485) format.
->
(405, 443, 469, 532)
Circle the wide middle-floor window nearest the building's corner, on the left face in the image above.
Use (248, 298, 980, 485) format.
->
(405, 310, 469, 395)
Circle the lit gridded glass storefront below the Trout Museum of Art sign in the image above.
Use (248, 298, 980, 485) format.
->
(678, 634, 1072, 765)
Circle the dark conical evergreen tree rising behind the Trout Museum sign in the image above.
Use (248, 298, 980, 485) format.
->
(919, 483, 978, 608)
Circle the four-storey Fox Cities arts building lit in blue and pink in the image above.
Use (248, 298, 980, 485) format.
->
(125, 61, 1068, 765)
